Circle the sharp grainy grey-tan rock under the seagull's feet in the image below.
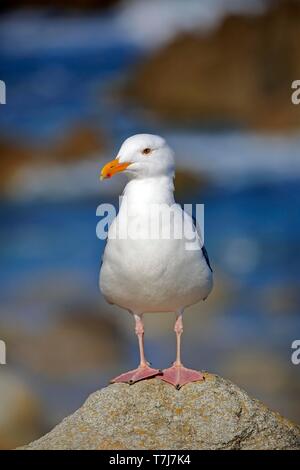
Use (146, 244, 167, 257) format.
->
(22, 373, 300, 450)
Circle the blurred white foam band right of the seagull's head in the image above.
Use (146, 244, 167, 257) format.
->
(166, 132, 300, 186)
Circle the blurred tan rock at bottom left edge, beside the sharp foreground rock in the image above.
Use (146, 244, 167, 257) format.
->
(0, 366, 43, 450)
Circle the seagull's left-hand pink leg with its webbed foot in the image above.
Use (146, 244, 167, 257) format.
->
(111, 314, 161, 384)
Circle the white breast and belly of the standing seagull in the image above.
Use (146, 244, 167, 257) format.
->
(100, 178, 212, 313)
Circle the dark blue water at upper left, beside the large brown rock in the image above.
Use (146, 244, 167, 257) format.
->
(0, 45, 142, 139)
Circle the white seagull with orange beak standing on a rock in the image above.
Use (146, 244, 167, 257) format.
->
(99, 134, 213, 389)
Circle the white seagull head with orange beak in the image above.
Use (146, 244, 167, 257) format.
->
(101, 134, 175, 179)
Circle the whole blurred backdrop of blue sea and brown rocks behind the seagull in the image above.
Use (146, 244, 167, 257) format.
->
(0, 0, 300, 448)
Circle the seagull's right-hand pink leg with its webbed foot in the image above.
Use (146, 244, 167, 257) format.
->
(160, 311, 204, 389)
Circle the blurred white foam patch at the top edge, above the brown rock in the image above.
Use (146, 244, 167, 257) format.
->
(118, 0, 266, 48)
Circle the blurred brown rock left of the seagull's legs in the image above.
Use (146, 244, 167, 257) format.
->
(10, 311, 124, 379)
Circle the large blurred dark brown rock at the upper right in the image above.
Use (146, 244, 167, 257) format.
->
(128, 0, 300, 130)
